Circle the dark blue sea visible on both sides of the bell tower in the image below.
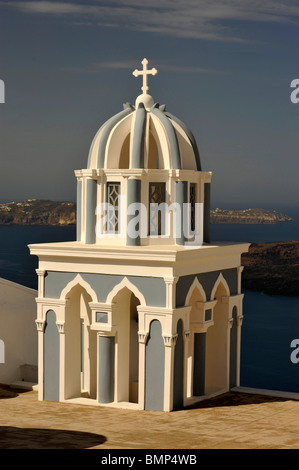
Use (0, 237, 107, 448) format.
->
(0, 205, 299, 393)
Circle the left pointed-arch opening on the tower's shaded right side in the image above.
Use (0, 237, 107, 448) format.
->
(186, 279, 206, 397)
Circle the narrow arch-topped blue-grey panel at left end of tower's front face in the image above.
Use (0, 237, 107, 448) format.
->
(44, 310, 60, 401)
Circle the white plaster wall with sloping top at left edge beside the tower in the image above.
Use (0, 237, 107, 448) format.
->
(0, 278, 37, 384)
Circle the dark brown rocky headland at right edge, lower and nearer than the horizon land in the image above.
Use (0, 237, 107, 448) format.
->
(242, 241, 299, 296)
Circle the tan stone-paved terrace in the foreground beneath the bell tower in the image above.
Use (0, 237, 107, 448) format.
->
(0, 386, 299, 449)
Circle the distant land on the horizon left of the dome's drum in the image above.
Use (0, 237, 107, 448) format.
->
(0, 199, 76, 225)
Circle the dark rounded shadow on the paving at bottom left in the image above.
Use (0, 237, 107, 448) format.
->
(0, 426, 106, 449)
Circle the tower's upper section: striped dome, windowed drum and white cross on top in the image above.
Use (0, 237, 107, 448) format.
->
(75, 59, 211, 246)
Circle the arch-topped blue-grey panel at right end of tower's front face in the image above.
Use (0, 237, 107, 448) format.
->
(145, 320, 165, 411)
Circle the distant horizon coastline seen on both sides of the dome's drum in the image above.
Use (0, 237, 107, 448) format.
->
(0, 199, 293, 225)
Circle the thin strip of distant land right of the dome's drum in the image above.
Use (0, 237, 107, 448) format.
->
(210, 209, 293, 224)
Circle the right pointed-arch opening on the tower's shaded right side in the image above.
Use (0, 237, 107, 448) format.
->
(206, 282, 229, 394)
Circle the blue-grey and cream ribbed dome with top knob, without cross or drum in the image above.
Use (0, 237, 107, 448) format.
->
(87, 97, 201, 171)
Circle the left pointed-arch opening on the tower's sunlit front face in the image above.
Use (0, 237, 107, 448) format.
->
(65, 284, 97, 399)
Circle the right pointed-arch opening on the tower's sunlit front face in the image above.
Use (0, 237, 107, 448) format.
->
(112, 287, 140, 403)
